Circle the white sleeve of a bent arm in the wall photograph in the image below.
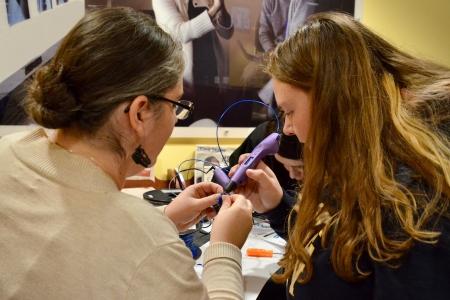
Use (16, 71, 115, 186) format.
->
(153, 0, 214, 44)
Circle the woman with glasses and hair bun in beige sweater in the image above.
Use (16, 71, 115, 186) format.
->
(0, 8, 252, 300)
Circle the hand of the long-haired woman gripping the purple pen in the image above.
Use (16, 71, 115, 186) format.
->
(229, 154, 283, 213)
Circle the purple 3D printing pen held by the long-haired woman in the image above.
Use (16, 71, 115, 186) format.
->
(214, 133, 280, 193)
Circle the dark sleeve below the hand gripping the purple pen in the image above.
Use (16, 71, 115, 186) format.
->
(264, 190, 297, 240)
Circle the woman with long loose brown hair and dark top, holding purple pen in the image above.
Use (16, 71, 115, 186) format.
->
(232, 13, 450, 299)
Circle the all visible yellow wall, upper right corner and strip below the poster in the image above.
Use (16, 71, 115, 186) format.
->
(155, 0, 450, 179)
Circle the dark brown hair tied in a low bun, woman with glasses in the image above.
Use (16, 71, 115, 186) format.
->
(25, 8, 184, 134)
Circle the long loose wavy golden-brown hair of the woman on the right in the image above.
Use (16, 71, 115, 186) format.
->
(266, 13, 450, 283)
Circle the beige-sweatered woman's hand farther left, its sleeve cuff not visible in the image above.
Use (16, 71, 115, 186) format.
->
(164, 182, 223, 232)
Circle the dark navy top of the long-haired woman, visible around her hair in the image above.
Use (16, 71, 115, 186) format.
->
(259, 126, 450, 300)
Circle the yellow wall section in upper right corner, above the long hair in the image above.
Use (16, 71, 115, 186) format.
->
(362, 0, 450, 67)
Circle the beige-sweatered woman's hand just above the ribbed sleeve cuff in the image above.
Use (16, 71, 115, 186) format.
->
(210, 194, 253, 248)
